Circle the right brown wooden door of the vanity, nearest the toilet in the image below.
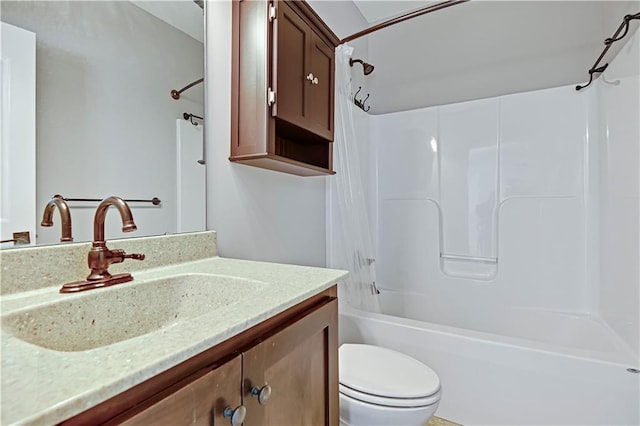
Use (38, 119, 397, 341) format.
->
(242, 299, 339, 426)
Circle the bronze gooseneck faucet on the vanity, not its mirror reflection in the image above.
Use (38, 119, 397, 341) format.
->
(60, 197, 144, 293)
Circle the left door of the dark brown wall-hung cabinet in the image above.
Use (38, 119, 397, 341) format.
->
(272, 2, 311, 128)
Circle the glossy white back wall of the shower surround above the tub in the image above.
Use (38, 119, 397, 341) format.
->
(371, 85, 598, 314)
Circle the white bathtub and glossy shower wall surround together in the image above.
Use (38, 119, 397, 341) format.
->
(356, 29, 640, 424)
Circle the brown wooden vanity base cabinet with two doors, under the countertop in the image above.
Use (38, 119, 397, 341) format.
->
(63, 286, 339, 426)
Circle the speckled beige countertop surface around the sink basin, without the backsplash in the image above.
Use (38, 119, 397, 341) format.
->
(0, 255, 347, 425)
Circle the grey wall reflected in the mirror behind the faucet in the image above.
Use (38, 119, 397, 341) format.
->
(0, 1, 204, 244)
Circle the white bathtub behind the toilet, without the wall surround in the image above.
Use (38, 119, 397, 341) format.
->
(340, 291, 640, 426)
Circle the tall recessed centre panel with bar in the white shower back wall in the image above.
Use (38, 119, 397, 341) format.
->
(437, 99, 499, 279)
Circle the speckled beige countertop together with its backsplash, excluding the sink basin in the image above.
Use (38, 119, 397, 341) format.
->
(1, 232, 347, 425)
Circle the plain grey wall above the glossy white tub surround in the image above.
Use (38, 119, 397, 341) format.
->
(368, 0, 640, 114)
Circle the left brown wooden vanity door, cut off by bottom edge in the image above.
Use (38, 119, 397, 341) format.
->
(122, 356, 242, 426)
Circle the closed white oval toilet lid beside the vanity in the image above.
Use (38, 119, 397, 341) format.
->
(339, 343, 440, 398)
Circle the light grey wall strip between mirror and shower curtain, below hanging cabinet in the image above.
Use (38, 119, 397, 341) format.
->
(205, 1, 327, 266)
